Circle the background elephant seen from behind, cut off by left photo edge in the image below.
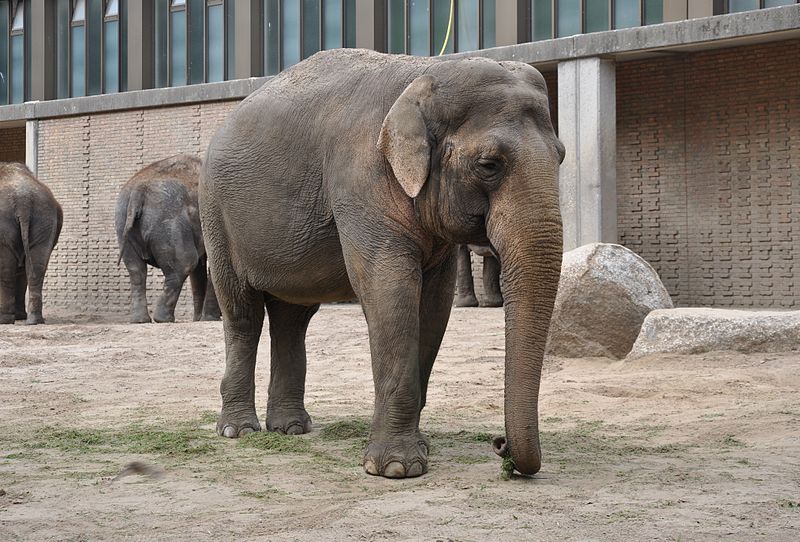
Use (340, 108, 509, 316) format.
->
(0, 163, 64, 324)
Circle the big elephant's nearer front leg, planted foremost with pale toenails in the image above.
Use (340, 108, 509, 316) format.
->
(348, 249, 428, 478)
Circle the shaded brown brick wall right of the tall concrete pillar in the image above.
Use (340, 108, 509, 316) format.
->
(617, 40, 800, 308)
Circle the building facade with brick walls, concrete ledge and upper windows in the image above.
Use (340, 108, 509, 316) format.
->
(0, 0, 800, 317)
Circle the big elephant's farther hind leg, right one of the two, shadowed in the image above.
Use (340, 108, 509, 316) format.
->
(266, 299, 319, 435)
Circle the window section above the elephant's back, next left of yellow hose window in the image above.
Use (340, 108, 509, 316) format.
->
(264, 0, 355, 75)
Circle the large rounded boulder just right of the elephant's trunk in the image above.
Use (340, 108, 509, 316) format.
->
(547, 243, 672, 359)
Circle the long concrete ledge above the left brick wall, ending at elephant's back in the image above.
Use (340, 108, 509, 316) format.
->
(0, 77, 269, 123)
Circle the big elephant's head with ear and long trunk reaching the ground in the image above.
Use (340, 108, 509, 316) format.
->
(378, 59, 564, 474)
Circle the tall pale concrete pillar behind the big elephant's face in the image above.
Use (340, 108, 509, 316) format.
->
(558, 57, 617, 251)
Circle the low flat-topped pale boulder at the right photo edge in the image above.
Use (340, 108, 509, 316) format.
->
(628, 308, 800, 359)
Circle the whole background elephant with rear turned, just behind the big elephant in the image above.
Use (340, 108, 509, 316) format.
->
(115, 154, 220, 324)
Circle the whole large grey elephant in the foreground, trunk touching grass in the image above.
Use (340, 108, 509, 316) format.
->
(200, 49, 564, 478)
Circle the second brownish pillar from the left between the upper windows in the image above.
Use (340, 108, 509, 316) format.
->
(127, 2, 155, 90)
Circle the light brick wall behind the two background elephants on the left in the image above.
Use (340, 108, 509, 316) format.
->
(38, 102, 237, 320)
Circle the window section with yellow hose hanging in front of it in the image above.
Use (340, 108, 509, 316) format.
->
(386, 0, 496, 56)
